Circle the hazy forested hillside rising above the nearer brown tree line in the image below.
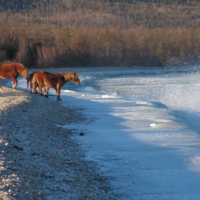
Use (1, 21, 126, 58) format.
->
(0, 0, 200, 28)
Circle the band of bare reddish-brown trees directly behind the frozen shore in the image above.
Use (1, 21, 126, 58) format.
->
(0, 27, 200, 68)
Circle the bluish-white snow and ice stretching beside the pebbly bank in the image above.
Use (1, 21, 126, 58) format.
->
(16, 66, 200, 200)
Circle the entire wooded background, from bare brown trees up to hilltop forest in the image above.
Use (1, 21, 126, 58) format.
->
(0, 0, 200, 68)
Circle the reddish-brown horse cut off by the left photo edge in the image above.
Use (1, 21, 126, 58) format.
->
(0, 63, 28, 89)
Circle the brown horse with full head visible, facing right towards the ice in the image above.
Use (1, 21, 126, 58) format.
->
(27, 71, 80, 101)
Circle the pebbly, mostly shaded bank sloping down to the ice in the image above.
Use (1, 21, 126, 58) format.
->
(0, 87, 117, 200)
